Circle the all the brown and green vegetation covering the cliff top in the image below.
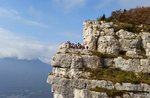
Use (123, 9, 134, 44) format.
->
(97, 7, 150, 33)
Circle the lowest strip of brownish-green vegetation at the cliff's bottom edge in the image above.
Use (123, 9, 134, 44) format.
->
(90, 87, 148, 97)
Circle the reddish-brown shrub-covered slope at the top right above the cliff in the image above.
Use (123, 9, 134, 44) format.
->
(110, 7, 150, 25)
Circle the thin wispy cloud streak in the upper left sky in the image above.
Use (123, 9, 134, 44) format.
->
(0, 8, 49, 28)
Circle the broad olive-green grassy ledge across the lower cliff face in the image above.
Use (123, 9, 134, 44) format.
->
(82, 67, 150, 84)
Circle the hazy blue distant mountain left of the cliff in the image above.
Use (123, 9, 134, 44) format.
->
(0, 58, 52, 98)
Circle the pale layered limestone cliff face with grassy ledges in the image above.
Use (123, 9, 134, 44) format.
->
(47, 21, 150, 98)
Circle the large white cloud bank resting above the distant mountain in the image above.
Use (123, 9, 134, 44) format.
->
(0, 28, 57, 63)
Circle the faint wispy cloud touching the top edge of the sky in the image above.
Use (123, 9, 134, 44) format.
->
(53, 0, 86, 11)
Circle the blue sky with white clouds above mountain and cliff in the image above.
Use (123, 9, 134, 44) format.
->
(0, 0, 150, 63)
